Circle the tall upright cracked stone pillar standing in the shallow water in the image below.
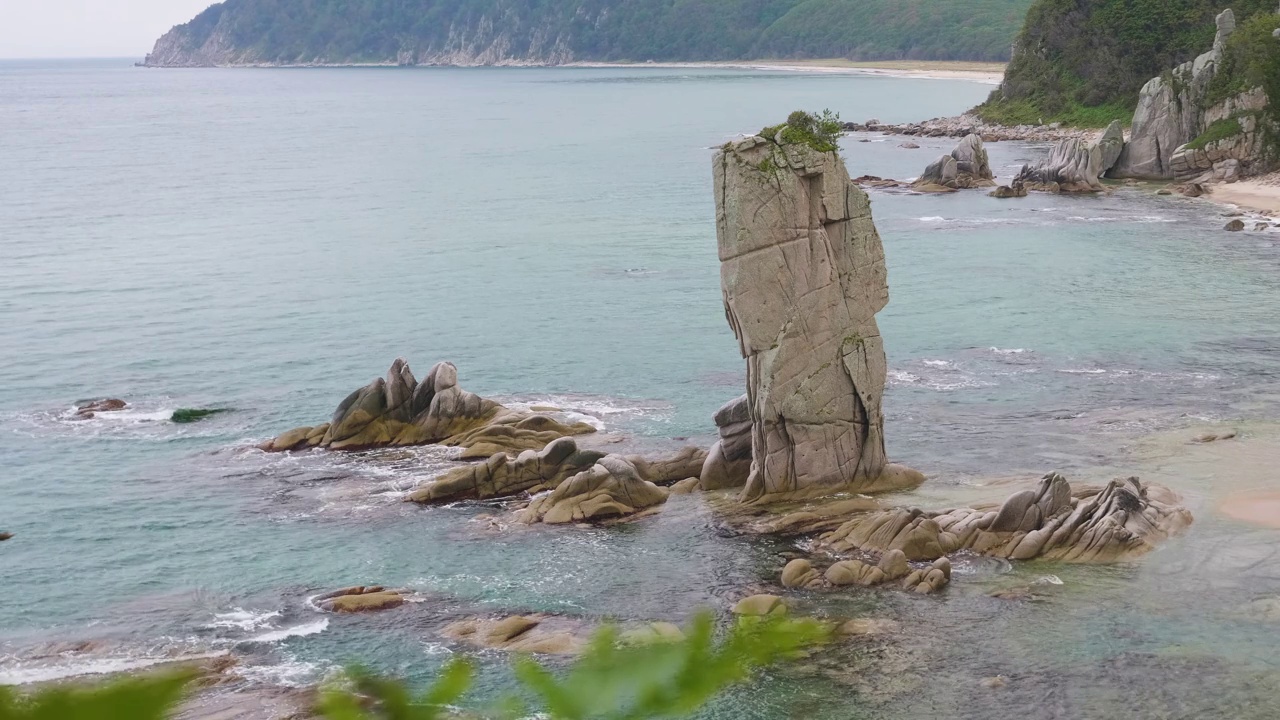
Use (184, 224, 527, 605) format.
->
(713, 126, 923, 501)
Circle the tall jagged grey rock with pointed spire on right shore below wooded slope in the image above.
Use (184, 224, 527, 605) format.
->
(1111, 9, 1267, 182)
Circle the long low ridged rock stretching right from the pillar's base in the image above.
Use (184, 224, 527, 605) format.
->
(820, 473, 1192, 562)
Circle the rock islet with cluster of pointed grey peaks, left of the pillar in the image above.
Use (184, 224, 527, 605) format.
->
(259, 359, 595, 457)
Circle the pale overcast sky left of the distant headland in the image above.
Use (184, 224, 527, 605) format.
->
(0, 0, 214, 59)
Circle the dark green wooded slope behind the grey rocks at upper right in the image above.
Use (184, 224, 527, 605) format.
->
(977, 0, 1276, 127)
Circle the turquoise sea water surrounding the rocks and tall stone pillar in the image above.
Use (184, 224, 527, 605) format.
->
(0, 63, 1280, 717)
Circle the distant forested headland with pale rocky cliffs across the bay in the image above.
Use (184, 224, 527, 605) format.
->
(148, 0, 1032, 65)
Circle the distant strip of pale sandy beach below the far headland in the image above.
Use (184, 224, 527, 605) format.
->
(568, 58, 1005, 85)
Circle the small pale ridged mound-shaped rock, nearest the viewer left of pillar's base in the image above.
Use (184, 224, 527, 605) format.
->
(518, 455, 669, 525)
